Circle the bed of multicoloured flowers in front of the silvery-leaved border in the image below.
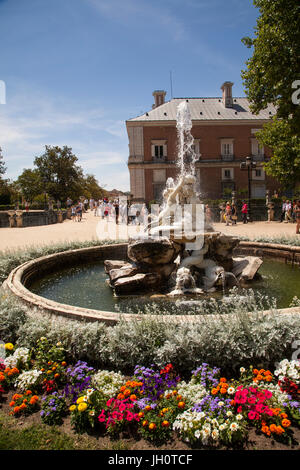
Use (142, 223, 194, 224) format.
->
(0, 338, 300, 448)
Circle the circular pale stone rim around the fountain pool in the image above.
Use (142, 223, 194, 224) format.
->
(3, 241, 300, 325)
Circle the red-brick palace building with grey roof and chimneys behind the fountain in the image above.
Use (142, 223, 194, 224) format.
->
(126, 82, 279, 202)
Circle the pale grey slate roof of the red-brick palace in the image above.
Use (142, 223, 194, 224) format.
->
(127, 98, 276, 122)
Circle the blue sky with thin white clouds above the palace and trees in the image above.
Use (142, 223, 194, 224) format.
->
(0, 0, 258, 190)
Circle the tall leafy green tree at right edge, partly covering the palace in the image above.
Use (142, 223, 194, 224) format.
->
(242, 0, 300, 186)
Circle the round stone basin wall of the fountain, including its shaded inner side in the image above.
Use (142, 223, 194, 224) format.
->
(3, 242, 300, 325)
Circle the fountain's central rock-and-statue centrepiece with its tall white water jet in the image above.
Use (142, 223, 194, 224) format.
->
(104, 101, 262, 297)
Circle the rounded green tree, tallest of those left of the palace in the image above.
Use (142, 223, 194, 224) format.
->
(34, 145, 83, 201)
